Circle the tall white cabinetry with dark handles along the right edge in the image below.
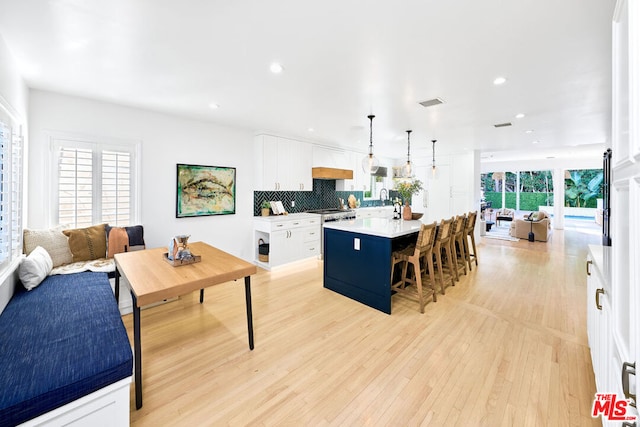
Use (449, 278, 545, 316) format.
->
(587, 0, 640, 425)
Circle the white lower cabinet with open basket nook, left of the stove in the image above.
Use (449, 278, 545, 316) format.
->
(254, 213, 321, 269)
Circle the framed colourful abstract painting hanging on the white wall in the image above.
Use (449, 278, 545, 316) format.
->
(176, 163, 236, 218)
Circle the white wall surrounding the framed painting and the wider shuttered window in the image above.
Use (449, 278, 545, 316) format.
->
(25, 90, 254, 261)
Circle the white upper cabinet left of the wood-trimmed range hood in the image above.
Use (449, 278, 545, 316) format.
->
(254, 135, 313, 191)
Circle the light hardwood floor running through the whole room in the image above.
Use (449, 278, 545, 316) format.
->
(123, 229, 599, 426)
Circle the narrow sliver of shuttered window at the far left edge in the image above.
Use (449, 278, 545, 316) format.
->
(0, 105, 22, 271)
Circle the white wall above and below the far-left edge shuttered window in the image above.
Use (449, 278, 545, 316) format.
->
(0, 33, 28, 312)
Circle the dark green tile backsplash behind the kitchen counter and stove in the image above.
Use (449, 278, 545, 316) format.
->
(253, 179, 395, 216)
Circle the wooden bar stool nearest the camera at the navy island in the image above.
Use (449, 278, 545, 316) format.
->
(391, 221, 437, 313)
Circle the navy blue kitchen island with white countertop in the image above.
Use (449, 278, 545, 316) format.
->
(323, 218, 422, 314)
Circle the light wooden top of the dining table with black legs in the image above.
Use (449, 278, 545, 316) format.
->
(114, 242, 257, 307)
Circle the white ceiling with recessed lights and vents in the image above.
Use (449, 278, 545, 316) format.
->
(0, 0, 614, 161)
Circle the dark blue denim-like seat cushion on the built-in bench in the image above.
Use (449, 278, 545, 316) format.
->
(0, 272, 133, 425)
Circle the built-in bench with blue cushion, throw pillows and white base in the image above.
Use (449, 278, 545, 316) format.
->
(0, 224, 144, 426)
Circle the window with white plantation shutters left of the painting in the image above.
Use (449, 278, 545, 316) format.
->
(53, 138, 137, 228)
